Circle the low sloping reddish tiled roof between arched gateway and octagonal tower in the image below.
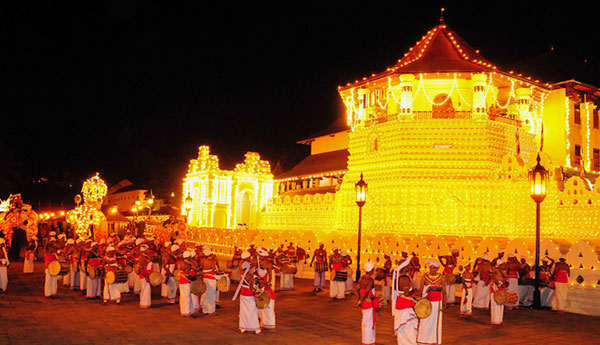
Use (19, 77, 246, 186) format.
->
(275, 149, 349, 180)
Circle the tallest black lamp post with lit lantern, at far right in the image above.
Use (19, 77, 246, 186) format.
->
(529, 153, 548, 309)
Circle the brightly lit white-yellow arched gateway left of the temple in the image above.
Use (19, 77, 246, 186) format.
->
(182, 146, 273, 229)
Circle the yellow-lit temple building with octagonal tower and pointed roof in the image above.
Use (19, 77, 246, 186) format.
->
(185, 22, 600, 312)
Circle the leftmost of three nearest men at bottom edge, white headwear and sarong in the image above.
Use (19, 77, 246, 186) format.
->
(357, 260, 379, 345)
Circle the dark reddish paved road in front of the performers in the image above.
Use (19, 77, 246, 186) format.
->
(0, 263, 600, 345)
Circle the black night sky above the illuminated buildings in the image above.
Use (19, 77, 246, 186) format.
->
(0, 1, 600, 207)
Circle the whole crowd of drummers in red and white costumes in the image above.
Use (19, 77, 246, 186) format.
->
(0, 232, 570, 344)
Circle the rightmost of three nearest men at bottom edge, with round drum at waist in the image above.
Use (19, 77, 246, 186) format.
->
(417, 261, 446, 344)
